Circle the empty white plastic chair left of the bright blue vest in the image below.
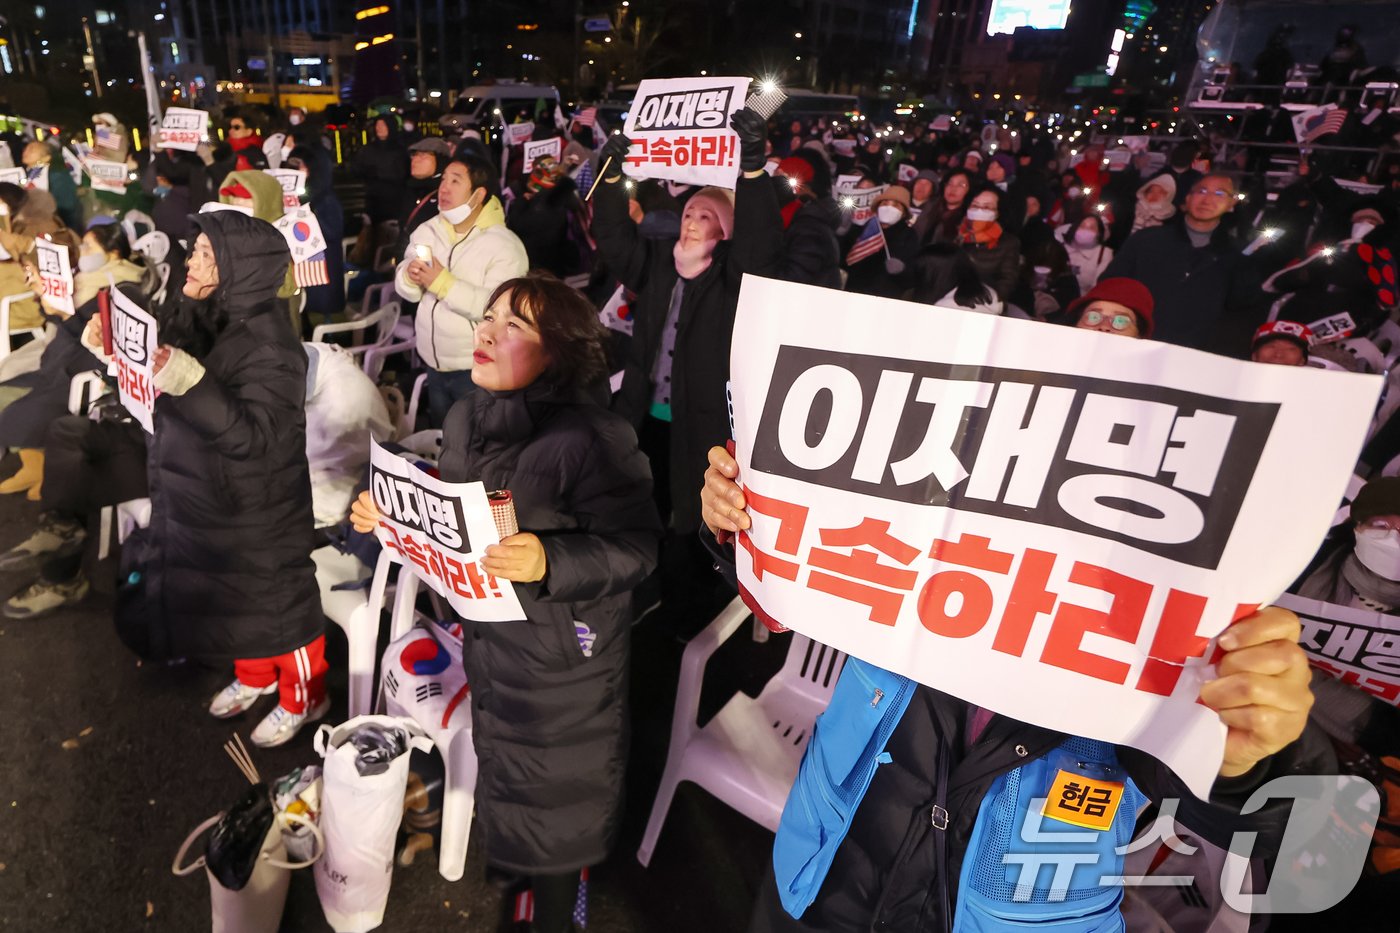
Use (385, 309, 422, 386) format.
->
(637, 597, 846, 866)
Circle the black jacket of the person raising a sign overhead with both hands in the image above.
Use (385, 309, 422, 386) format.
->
(592, 168, 783, 534)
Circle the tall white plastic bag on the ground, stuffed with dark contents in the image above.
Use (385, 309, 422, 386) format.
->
(315, 716, 433, 933)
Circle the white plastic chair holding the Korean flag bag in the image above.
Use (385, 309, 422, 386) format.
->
(379, 560, 477, 881)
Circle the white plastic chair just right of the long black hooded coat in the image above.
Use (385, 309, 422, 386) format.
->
(311, 545, 393, 719)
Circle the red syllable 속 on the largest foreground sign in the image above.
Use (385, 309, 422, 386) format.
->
(806, 518, 918, 625)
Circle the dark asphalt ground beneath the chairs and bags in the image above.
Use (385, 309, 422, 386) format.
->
(0, 465, 785, 933)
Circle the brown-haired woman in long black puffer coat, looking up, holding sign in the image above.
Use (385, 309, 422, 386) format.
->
(350, 273, 661, 933)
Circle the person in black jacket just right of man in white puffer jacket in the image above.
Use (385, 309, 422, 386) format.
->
(505, 156, 589, 279)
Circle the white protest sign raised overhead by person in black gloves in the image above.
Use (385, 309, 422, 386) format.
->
(623, 77, 749, 188)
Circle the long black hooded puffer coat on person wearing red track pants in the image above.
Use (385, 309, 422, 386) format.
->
(146, 210, 325, 663)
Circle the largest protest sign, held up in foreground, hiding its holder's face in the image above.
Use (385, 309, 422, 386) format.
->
(731, 276, 1379, 797)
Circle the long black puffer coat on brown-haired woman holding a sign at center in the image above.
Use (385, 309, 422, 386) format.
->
(440, 382, 661, 874)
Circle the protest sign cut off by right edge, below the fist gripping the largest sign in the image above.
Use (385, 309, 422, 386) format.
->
(1277, 593, 1400, 706)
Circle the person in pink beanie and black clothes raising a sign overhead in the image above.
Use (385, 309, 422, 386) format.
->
(592, 108, 789, 637)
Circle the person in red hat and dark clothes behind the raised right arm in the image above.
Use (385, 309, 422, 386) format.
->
(767, 149, 843, 289)
